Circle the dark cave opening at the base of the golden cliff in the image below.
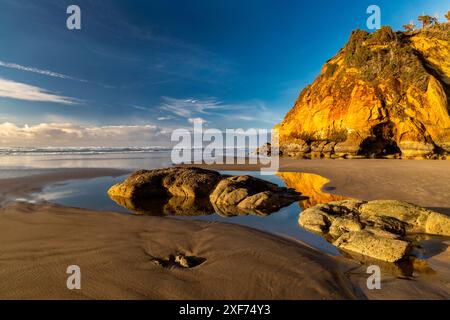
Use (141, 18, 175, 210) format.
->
(359, 121, 401, 158)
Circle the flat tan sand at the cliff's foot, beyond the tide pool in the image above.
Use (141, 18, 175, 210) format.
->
(195, 158, 450, 214)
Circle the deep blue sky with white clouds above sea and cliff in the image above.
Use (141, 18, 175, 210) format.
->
(0, 0, 450, 148)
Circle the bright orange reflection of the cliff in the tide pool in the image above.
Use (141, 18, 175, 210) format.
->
(277, 172, 349, 210)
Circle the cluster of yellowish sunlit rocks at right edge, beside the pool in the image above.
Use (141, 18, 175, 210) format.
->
(299, 200, 450, 262)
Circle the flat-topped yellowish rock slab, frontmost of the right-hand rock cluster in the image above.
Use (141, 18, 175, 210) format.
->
(333, 231, 410, 262)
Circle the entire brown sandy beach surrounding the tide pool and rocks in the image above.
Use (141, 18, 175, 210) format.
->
(0, 159, 450, 299)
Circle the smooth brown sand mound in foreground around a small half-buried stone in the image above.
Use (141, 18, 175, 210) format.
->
(0, 203, 361, 299)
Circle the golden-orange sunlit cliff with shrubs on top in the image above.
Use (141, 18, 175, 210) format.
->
(276, 23, 450, 159)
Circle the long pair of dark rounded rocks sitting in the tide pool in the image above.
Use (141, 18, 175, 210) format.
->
(108, 167, 301, 216)
